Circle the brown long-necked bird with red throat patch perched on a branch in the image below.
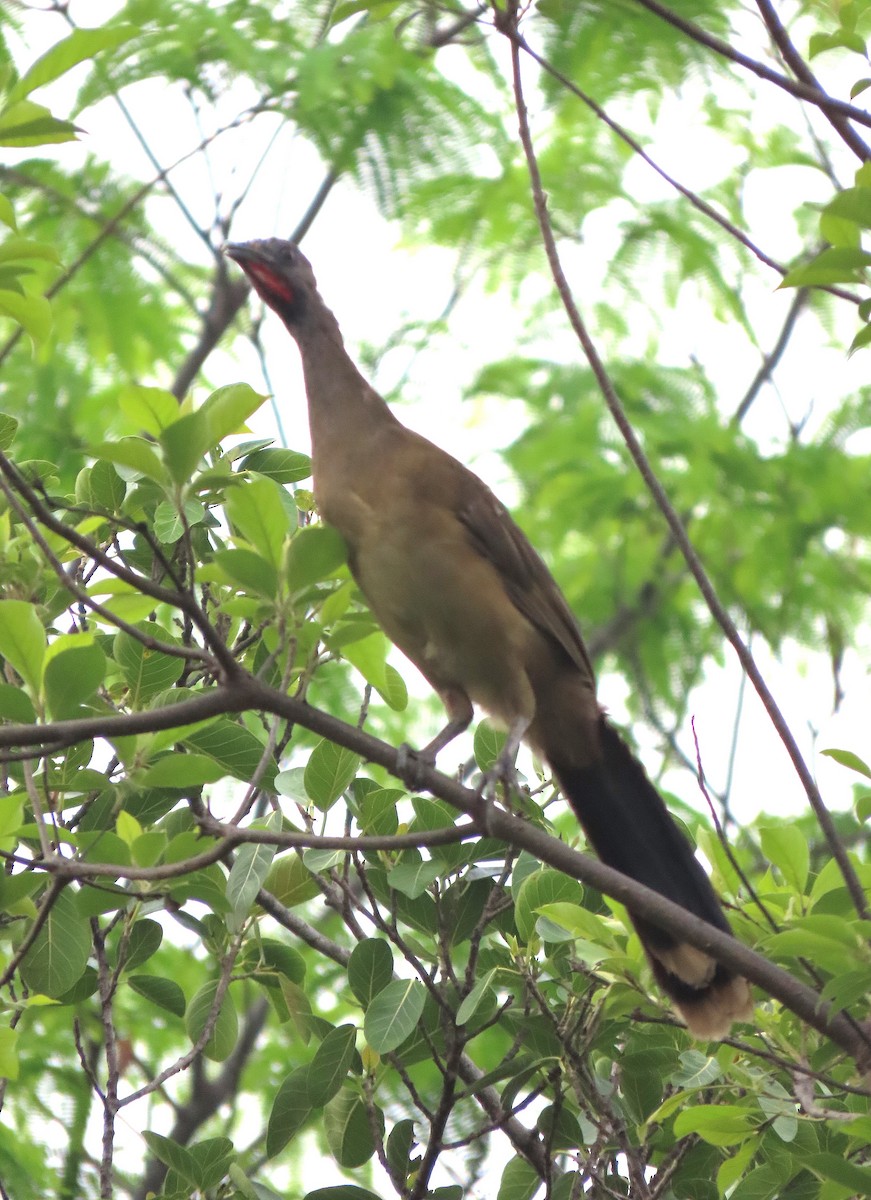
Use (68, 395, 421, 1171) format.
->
(226, 238, 752, 1038)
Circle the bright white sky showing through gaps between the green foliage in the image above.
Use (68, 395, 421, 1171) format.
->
(0, 0, 871, 1190)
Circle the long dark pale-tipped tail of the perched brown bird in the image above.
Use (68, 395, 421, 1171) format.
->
(551, 718, 752, 1038)
